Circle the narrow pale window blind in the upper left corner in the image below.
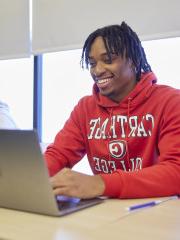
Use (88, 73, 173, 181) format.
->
(0, 0, 30, 59)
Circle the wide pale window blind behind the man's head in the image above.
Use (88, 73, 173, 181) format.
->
(32, 0, 180, 54)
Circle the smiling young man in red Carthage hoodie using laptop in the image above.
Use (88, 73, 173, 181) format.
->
(45, 22, 180, 198)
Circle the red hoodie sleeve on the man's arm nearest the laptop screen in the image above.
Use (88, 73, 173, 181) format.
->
(44, 98, 86, 176)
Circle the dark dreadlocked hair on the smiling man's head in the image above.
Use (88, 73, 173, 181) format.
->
(80, 22, 152, 81)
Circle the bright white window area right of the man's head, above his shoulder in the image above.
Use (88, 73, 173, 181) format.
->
(143, 38, 180, 89)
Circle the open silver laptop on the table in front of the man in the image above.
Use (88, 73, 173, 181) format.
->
(0, 129, 103, 216)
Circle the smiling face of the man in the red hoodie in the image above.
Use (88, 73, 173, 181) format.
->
(89, 37, 136, 102)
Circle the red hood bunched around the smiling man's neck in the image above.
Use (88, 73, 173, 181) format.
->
(93, 72, 157, 108)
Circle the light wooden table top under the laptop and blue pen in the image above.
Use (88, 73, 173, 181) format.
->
(0, 199, 180, 240)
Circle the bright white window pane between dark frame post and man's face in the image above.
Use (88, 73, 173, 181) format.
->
(42, 50, 93, 142)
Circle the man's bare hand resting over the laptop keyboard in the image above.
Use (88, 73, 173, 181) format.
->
(50, 168, 105, 199)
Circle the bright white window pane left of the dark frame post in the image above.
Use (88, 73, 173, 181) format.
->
(0, 58, 33, 129)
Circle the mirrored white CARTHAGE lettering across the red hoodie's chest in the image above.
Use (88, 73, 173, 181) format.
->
(87, 113, 154, 139)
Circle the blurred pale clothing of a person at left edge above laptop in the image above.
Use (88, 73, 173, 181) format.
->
(0, 101, 17, 129)
